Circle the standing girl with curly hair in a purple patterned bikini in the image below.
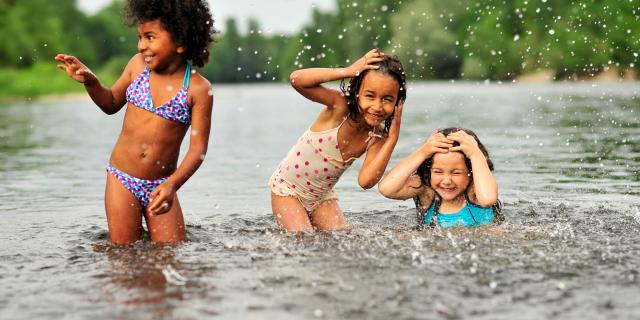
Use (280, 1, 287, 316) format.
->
(55, 0, 216, 244)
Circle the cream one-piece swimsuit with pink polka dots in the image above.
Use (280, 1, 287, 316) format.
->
(269, 119, 379, 212)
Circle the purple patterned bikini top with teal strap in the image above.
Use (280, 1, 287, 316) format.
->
(127, 64, 191, 125)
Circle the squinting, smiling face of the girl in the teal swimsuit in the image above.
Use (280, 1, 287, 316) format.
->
(431, 152, 471, 201)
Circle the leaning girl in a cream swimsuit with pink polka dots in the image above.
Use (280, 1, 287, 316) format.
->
(269, 49, 406, 232)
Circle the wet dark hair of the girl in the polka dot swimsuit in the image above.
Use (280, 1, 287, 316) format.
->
(340, 55, 407, 132)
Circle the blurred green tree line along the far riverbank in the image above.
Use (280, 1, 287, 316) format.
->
(0, 0, 640, 82)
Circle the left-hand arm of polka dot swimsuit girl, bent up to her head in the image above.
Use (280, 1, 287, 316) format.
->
(289, 49, 384, 107)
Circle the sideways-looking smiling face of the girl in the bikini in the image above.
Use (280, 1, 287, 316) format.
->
(138, 19, 184, 70)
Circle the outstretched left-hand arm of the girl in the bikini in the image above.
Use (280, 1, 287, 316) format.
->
(55, 54, 137, 114)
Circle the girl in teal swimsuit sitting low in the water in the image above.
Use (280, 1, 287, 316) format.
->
(378, 128, 502, 228)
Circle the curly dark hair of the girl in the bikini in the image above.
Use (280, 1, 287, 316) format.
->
(124, 0, 218, 67)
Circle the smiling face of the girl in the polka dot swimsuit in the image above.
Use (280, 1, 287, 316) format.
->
(358, 70, 400, 127)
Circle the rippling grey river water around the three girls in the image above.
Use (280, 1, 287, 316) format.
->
(0, 83, 640, 320)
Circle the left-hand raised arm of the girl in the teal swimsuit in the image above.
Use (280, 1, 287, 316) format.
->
(378, 132, 453, 200)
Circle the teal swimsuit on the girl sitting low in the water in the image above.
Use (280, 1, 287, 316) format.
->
(415, 195, 502, 228)
